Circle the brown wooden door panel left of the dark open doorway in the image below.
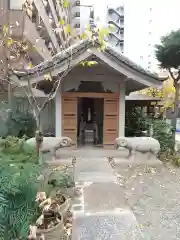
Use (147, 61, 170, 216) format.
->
(62, 96, 77, 145)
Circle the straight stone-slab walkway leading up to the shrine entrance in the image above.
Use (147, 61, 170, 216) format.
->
(72, 157, 144, 240)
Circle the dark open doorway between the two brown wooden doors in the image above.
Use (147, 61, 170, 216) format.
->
(77, 97, 104, 147)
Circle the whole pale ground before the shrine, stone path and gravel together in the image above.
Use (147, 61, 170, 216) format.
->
(46, 149, 180, 240)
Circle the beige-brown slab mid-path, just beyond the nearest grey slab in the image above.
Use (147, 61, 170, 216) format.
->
(83, 182, 127, 212)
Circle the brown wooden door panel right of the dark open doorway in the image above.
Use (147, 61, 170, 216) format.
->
(103, 98, 119, 147)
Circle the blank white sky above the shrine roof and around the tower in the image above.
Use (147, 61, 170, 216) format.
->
(81, 0, 180, 70)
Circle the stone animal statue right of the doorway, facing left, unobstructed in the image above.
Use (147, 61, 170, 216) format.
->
(114, 137, 160, 157)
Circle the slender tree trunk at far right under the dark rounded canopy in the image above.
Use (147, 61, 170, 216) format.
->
(171, 80, 180, 150)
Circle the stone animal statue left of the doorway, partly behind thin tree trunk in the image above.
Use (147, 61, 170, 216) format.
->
(26, 137, 72, 157)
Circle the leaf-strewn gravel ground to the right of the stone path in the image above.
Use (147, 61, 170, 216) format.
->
(114, 163, 180, 240)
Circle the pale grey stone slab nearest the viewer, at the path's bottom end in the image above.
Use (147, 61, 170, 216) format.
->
(72, 210, 145, 240)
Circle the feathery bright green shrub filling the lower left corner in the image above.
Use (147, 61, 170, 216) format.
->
(0, 164, 39, 240)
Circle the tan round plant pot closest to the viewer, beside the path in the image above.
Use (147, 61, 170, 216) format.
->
(37, 213, 64, 240)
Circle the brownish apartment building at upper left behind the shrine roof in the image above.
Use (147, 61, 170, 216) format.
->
(0, 0, 80, 75)
